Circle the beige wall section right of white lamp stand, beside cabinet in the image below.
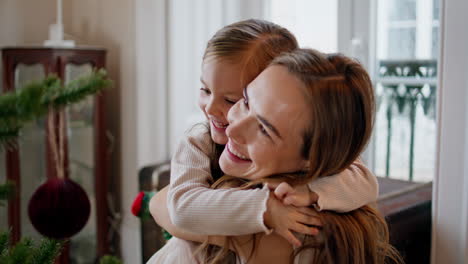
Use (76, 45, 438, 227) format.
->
(64, 0, 141, 263)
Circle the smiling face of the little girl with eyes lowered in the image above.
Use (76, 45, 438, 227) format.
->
(198, 58, 244, 145)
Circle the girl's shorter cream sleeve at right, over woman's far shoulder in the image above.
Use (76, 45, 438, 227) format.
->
(308, 159, 379, 212)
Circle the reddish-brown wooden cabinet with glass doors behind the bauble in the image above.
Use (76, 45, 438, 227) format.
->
(2, 47, 109, 264)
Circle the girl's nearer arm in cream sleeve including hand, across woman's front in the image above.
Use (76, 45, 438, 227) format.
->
(167, 128, 320, 245)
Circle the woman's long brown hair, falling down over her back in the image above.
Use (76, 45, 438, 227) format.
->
(197, 49, 403, 264)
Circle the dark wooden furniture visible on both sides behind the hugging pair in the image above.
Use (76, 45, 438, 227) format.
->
(139, 162, 432, 263)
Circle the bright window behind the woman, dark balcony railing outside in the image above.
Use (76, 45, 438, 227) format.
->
(265, 0, 439, 182)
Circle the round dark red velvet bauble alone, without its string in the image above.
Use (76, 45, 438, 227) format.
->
(28, 178, 91, 239)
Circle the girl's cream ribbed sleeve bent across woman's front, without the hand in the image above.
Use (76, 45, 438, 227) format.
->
(167, 128, 269, 235)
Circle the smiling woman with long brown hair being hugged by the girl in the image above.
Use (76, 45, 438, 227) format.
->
(148, 49, 400, 263)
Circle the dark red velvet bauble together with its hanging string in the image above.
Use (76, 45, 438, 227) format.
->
(28, 108, 91, 239)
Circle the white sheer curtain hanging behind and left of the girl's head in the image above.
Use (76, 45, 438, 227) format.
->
(167, 0, 263, 153)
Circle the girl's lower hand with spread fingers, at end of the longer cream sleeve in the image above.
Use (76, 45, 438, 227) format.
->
(264, 192, 321, 247)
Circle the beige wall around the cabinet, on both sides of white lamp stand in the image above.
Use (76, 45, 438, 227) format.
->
(0, 0, 141, 263)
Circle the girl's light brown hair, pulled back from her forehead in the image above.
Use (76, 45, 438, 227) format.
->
(203, 19, 298, 182)
